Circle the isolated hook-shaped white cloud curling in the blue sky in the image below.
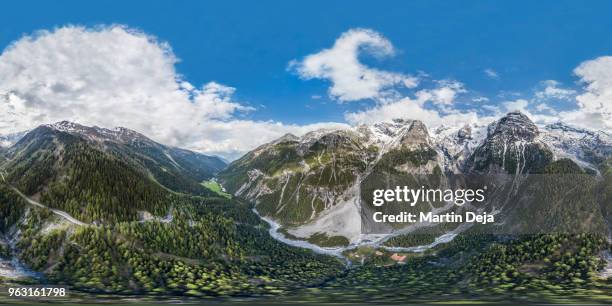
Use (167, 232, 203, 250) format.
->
(289, 29, 418, 102)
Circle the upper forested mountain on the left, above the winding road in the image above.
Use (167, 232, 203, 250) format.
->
(2, 123, 227, 223)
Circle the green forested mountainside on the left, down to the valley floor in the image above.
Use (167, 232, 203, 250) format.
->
(0, 123, 344, 296)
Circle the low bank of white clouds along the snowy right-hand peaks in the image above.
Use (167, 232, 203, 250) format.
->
(322, 31, 612, 131)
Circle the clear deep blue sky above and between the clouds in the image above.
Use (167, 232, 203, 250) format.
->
(0, 1, 612, 159)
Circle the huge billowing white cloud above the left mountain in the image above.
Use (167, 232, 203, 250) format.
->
(0, 26, 340, 158)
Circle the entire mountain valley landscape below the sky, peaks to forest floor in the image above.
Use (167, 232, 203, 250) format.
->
(0, 112, 612, 303)
